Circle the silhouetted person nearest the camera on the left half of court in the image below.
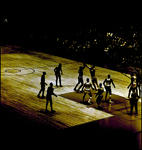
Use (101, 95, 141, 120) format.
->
(45, 82, 57, 112)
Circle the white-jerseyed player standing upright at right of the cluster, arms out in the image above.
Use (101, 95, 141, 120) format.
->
(103, 75, 115, 103)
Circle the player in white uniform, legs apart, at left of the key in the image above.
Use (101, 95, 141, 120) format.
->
(82, 78, 94, 104)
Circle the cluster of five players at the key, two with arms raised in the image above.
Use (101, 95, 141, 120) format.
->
(74, 64, 115, 108)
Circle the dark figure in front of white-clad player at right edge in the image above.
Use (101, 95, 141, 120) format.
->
(130, 91, 139, 115)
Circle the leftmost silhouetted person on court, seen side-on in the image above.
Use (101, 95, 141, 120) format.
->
(37, 72, 47, 98)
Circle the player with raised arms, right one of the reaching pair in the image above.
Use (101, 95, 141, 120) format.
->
(86, 65, 98, 90)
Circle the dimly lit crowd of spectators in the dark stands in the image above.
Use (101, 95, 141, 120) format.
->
(57, 26, 142, 67)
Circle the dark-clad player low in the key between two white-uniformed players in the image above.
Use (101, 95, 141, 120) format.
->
(95, 83, 104, 109)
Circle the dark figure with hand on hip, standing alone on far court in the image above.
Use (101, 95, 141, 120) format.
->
(54, 63, 63, 87)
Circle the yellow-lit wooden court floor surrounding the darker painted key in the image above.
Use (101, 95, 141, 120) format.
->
(1, 45, 141, 148)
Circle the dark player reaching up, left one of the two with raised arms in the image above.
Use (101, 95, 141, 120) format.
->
(74, 64, 85, 91)
